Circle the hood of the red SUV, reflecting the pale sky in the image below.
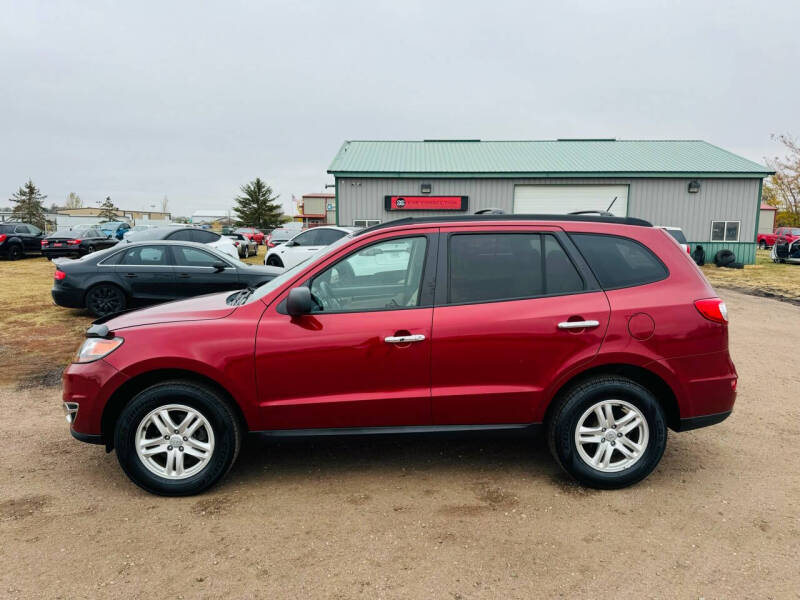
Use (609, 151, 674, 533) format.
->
(99, 291, 236, 331)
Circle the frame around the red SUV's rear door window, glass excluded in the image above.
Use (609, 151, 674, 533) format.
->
(434, 227, 601, 307)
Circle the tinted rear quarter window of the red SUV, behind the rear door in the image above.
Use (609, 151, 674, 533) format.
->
(571, 233, 669, 289)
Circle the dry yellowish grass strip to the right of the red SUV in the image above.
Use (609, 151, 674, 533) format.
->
(703, 250, 800, 302)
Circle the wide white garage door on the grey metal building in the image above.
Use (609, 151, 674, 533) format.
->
(514, 184, 628, 217)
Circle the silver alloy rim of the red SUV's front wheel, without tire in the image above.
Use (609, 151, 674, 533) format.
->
(135, 404, 214, 480)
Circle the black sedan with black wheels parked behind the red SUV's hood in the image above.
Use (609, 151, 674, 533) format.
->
(52, 240, 283, 316)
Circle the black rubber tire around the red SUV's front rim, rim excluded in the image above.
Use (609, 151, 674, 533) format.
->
(114, 380, 242, 496)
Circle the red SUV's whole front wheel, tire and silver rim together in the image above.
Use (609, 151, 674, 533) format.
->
(114, 381, 242, 496)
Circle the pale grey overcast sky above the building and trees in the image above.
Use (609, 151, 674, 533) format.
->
(0, 0, 800, 215)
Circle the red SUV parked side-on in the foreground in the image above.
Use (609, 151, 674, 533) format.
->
(63, 215, 737, 495)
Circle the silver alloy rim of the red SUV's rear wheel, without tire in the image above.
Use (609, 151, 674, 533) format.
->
(575, 400, 650, 473)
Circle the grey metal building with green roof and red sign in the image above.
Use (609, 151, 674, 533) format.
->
(328, 139, 772, 263)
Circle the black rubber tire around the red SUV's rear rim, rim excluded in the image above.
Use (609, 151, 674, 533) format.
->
(547, 376, 667, 489)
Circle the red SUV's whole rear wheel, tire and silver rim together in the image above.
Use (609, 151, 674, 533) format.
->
(548, 376, 667, 489)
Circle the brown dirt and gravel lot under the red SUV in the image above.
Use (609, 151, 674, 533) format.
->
(0, 290, 800, 600)
